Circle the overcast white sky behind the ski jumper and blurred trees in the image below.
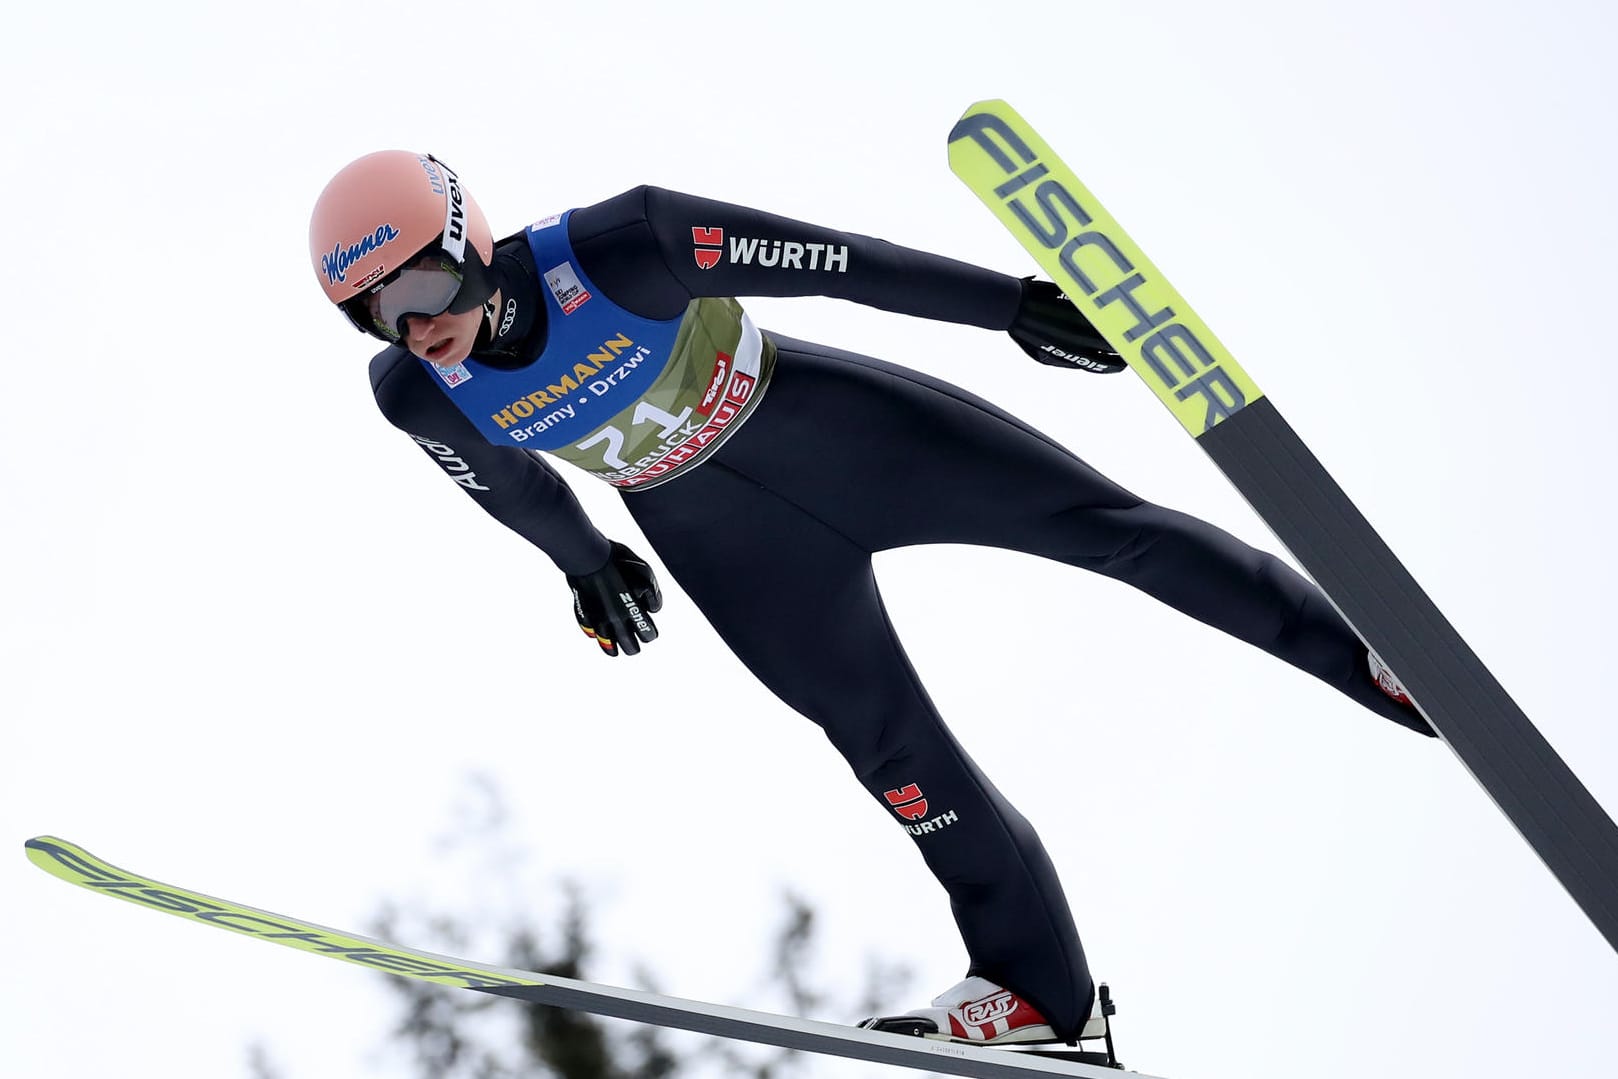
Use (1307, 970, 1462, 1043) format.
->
(0, 0, 1618, 1079)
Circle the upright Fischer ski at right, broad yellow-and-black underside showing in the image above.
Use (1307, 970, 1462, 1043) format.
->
(950, 100, 1618, 948)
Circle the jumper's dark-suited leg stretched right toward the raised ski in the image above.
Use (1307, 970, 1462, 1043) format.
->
(736, 338, 1430, 733)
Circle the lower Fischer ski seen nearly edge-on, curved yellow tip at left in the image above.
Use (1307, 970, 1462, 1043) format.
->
(24, 836, 1150, 1079)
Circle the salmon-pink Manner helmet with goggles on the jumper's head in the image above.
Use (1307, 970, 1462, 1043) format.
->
(309, 150, 495, 345)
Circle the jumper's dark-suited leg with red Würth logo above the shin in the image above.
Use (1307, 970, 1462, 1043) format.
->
(625, 461, 1094, 1034)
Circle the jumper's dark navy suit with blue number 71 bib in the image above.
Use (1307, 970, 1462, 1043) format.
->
(371, 188, 1424, 1035)
